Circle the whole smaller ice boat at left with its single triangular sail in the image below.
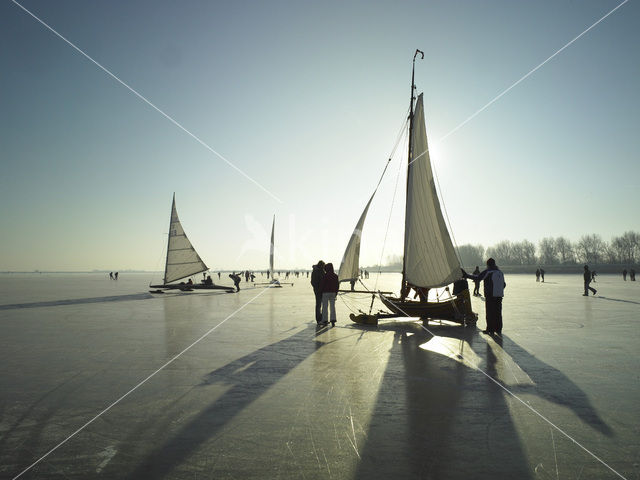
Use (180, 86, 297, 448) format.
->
(150, 193, 235, 292)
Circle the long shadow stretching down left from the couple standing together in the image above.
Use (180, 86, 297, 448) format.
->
(117, 327, 322, 479)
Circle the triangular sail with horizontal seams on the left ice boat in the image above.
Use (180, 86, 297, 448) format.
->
(164, 195, 208, 284)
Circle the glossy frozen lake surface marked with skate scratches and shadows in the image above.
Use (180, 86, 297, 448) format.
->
(0, 274, 640, 479)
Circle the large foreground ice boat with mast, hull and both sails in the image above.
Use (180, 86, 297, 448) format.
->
(339, 50, 477, 325)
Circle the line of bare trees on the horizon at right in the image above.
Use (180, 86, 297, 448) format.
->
(458, 231, 640, 267)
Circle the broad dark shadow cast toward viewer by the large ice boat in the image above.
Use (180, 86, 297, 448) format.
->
(356, 323, 532, 480)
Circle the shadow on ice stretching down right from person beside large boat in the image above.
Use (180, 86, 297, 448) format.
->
(487, 336, 613, 436)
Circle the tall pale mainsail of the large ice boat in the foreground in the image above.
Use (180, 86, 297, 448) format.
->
(404, 94, 461, 288)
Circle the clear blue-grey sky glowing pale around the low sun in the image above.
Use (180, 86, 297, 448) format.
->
(0, 0, 640, 271)
